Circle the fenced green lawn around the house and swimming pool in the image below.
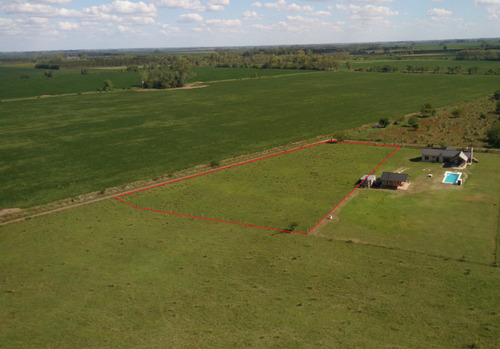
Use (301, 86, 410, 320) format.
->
(320, 148, 500, 265)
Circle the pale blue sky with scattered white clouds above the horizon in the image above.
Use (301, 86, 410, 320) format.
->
(0, 0, 500, 52)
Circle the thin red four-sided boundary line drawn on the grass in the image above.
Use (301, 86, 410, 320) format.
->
(114, 140, 401, 235)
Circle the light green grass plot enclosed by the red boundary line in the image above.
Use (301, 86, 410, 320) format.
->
(121, 143, 395, 233)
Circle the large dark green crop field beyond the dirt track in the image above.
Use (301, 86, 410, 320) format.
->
(0, 69, 498, 208)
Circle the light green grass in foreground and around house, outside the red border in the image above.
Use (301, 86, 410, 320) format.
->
(0, 150, 500, 348)
